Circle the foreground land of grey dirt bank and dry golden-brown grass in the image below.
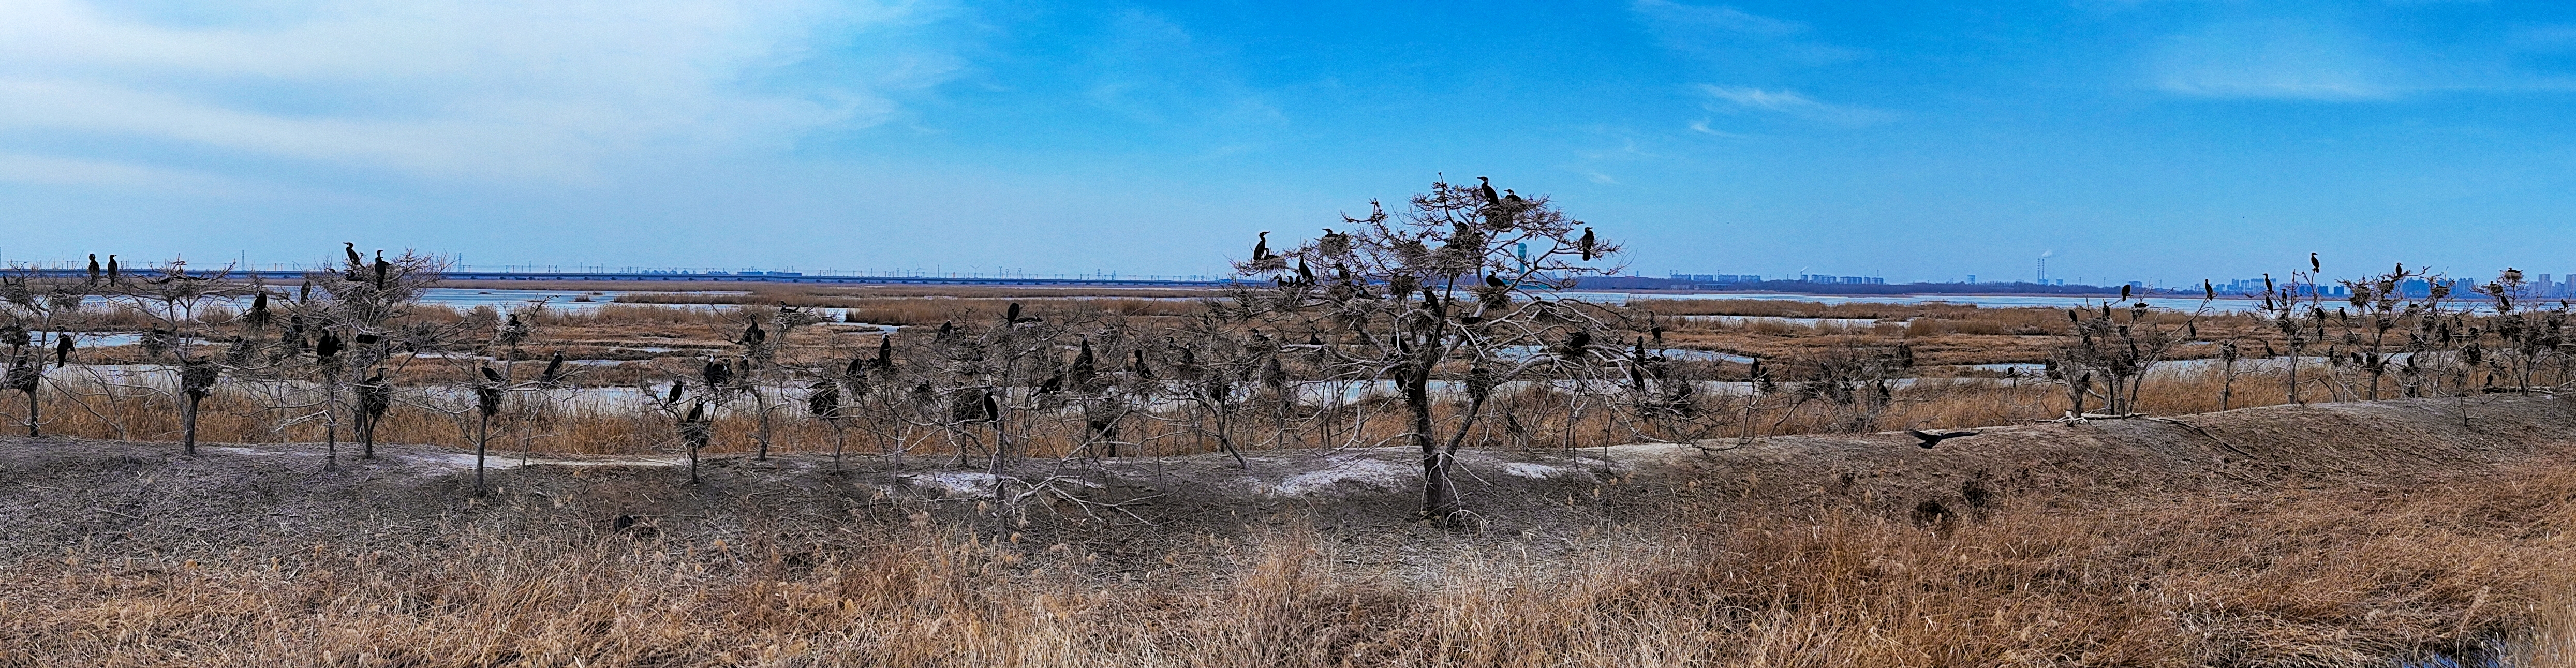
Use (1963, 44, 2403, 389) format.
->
(0, 397, 2576, 665)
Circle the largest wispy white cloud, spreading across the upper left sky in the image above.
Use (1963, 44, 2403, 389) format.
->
(0, 0, 958, 178)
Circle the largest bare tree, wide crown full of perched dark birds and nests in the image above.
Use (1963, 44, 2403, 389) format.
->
(1229, 178, 1620, 521)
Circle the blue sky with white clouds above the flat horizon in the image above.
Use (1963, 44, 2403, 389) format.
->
(0, 0, 2576, 284)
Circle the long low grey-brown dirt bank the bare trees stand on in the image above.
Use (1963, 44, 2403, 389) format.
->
(0, 397, 2576, 560)
